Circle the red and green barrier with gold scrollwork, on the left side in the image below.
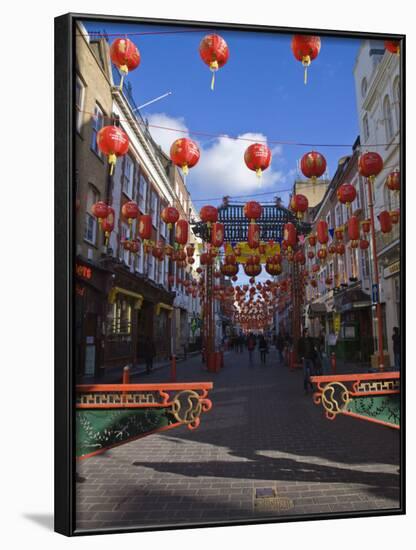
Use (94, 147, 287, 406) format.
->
(75, 382, 213, 460)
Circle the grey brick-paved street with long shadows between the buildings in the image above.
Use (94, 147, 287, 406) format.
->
(76, 350, 400, 529)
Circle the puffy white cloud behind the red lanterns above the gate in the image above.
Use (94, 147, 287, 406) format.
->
(148, 113, 287, 196)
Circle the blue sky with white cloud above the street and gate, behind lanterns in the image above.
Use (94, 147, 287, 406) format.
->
(81, 22, 360, 209)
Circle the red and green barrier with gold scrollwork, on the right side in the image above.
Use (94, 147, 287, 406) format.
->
(311, 372, 400, 429)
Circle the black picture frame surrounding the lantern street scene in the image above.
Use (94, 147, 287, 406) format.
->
(54, 13, 406, 536)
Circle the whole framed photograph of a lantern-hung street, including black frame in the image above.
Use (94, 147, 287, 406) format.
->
(55, 14, 406, 536)
